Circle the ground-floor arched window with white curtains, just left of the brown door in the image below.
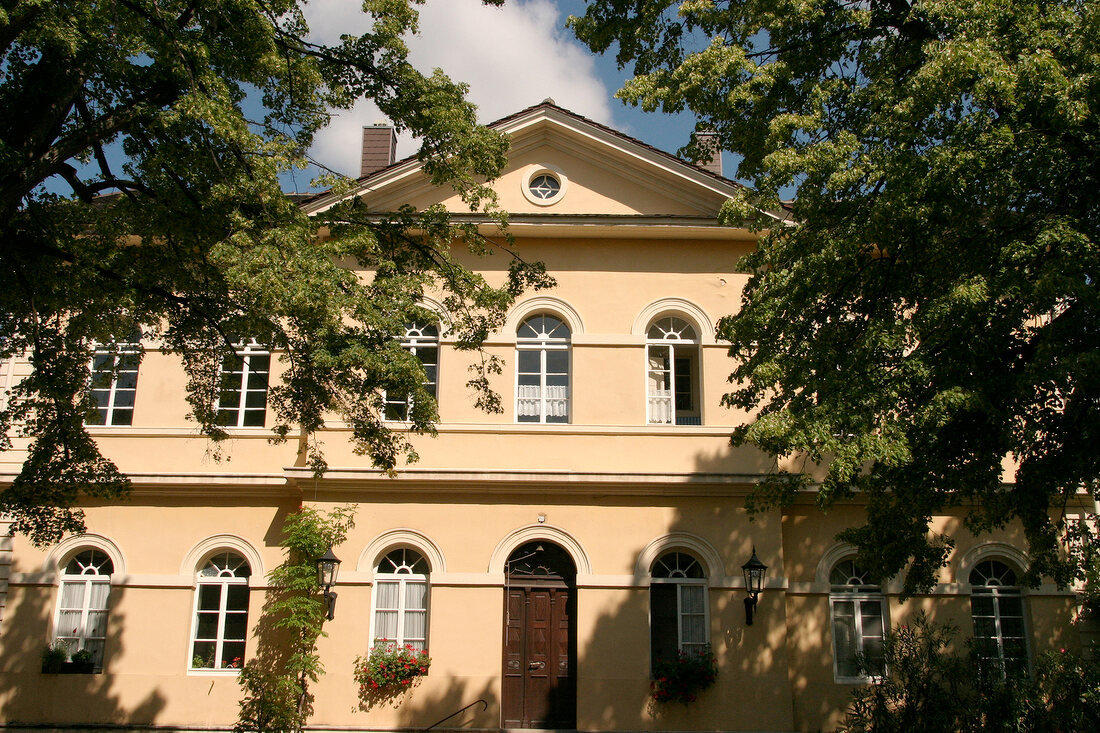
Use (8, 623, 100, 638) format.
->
(371, 547, 431, 649)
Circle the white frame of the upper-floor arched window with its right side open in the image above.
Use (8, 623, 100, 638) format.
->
(644, 315, 703, 425)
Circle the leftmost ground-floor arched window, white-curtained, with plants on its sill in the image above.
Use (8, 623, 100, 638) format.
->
(54, 548, 114, 669)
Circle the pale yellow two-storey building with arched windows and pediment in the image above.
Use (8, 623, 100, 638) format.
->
(0, 101, 1077, 731)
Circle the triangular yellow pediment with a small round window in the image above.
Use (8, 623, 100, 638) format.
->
(304, 101, 783, 219)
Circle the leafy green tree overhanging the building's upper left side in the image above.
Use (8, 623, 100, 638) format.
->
(0, 0, 547, 544)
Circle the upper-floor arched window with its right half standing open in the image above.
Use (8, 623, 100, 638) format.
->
(646, 316, 703, 425)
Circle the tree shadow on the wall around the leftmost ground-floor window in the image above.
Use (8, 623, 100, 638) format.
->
(0, 564, 166, 727)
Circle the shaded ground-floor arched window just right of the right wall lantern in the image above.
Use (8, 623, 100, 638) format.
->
(829, 558, 886, 680)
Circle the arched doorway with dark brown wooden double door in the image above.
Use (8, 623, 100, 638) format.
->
(501, 539, 576, 729)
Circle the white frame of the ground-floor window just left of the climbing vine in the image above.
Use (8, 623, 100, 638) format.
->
(187, 550, 252, 675)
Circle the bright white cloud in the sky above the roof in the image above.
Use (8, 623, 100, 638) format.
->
(306, 0, 612, 175)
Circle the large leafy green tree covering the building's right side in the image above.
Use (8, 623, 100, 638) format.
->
(570, 0, 1100, 592)
